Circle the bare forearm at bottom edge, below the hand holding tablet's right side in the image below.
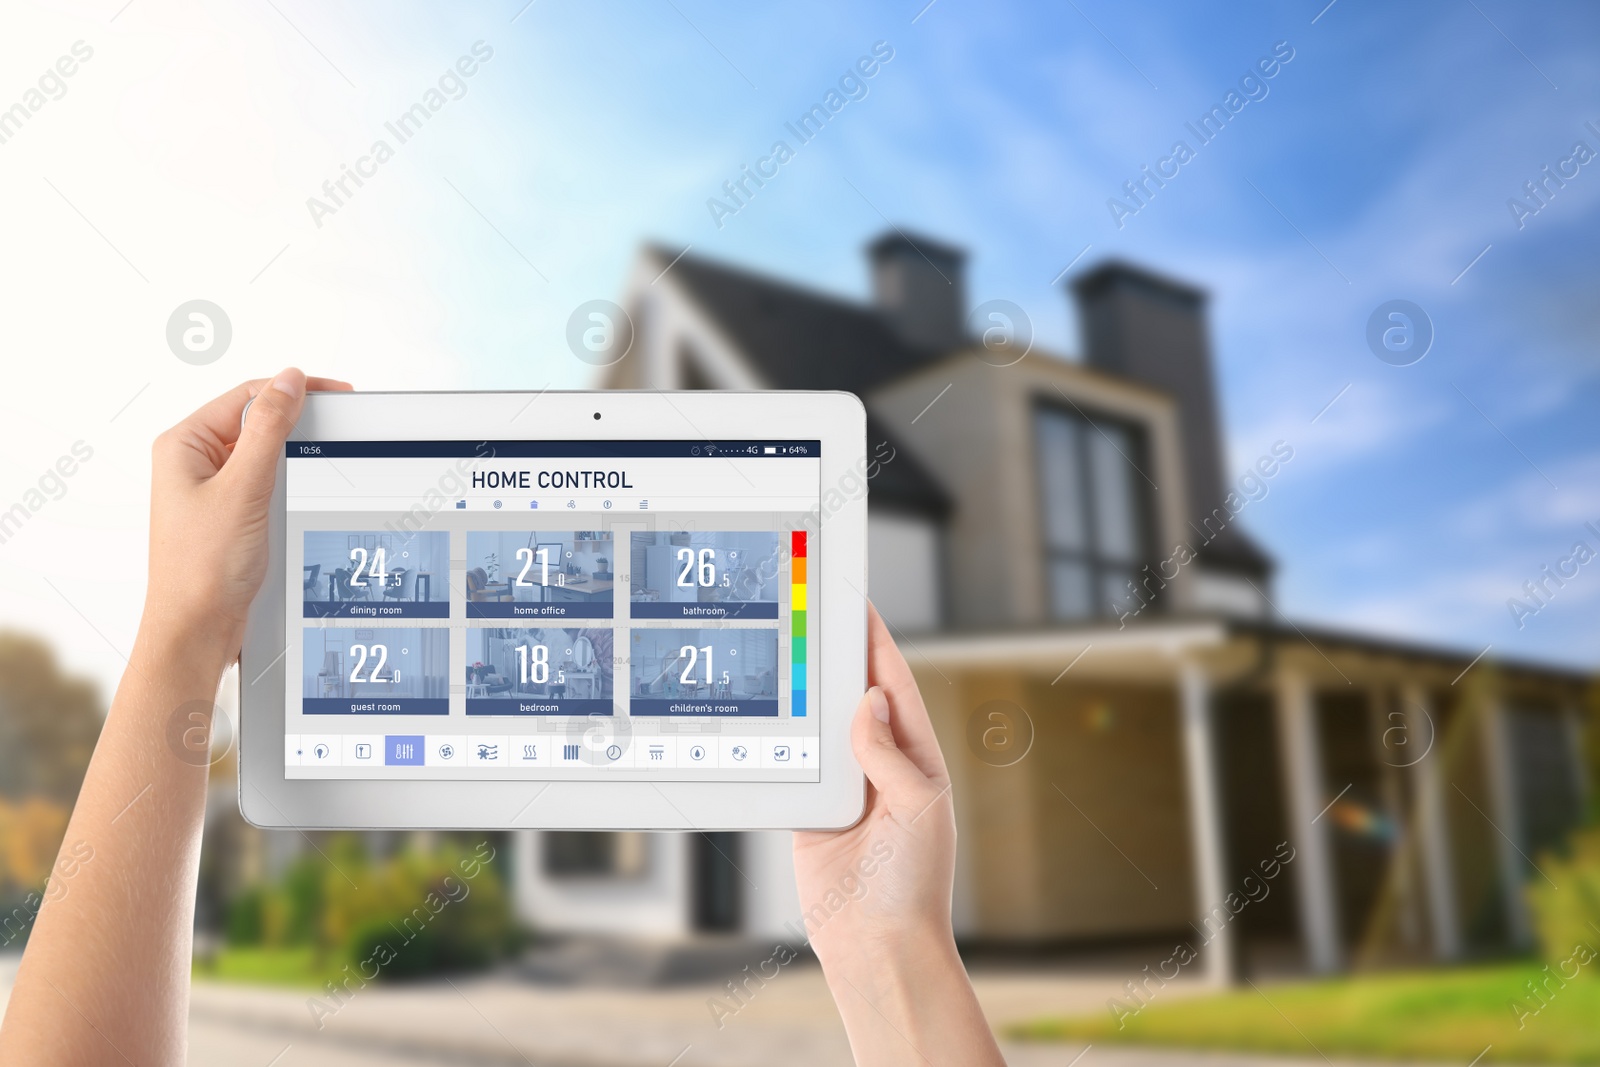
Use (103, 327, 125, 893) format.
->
(822, 934, 1005, 1067)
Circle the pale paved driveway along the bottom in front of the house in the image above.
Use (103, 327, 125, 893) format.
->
(0, 955, 1497, 1067)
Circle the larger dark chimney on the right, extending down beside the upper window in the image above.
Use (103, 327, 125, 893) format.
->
(1072, 261, 1232, 559)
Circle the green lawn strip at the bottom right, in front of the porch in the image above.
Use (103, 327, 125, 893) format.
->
(1011, 963, 1600, 1067)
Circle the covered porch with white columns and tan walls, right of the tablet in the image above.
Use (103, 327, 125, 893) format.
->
(898, 619, 1587, 982)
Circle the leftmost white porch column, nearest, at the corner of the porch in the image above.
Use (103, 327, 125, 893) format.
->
(1178, 662, 1238, 985)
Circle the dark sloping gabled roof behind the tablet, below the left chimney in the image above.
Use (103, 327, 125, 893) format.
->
(651, 246, 950, 515)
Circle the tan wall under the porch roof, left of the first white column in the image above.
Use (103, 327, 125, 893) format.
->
(914, 662, 1195, 941)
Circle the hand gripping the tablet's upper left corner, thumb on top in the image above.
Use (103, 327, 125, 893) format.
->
(144, 368, 350, 664)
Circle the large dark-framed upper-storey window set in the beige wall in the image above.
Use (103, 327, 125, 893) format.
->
(1034, 406, 1146, 619)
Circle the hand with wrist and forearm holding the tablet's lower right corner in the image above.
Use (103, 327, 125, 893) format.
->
(795, 605, 1005, 1067)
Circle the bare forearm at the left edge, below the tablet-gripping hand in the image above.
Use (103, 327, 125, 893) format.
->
(0, 616, 226, 1064)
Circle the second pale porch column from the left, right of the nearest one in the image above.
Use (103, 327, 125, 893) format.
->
(1277, 667, 1342, 974)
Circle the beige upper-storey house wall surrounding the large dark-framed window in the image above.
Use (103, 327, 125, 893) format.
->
(867, 354, 1194, 627)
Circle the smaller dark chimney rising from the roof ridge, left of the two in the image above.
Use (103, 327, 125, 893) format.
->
(867, 230, 968, 352)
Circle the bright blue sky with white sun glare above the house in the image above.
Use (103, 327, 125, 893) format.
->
(0, 0, 1600, 694)
